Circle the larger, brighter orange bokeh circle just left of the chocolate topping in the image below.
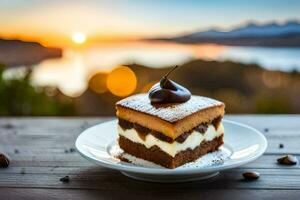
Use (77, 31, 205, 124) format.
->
(106, 66, 137, 97)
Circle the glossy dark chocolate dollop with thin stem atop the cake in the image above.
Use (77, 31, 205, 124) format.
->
(149, 66, 191, 103)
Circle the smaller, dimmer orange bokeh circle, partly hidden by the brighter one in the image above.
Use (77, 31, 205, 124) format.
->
(89, 71, 107, 94)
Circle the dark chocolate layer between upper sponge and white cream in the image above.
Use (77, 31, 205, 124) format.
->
(119, 117, 222, 143)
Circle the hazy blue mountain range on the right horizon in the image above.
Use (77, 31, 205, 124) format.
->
(154, 21, 300, 47)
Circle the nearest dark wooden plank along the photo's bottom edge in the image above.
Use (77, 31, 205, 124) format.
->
(0, 188, 300, 200)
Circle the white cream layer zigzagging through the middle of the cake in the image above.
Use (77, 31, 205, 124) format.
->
(118, 123, 224, 157)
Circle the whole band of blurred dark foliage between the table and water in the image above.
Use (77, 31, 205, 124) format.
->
(0, 60, 300, 116)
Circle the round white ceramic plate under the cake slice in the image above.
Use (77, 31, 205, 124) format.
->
(76, 120, 267, 182)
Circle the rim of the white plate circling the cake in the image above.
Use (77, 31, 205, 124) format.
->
(75, 119, 268, 175)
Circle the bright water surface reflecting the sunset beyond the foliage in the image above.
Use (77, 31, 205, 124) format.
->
(7, 42, 300, 96)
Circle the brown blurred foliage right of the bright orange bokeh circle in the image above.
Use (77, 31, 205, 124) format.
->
(125, 60, 300, 114)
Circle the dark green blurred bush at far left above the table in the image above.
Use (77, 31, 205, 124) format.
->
(0, 65, 76, 116)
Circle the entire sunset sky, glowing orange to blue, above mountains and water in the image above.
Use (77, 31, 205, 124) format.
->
(0, 0, 300, 46)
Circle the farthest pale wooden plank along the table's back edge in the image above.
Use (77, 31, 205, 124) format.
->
(0, 115, 300, 136)
